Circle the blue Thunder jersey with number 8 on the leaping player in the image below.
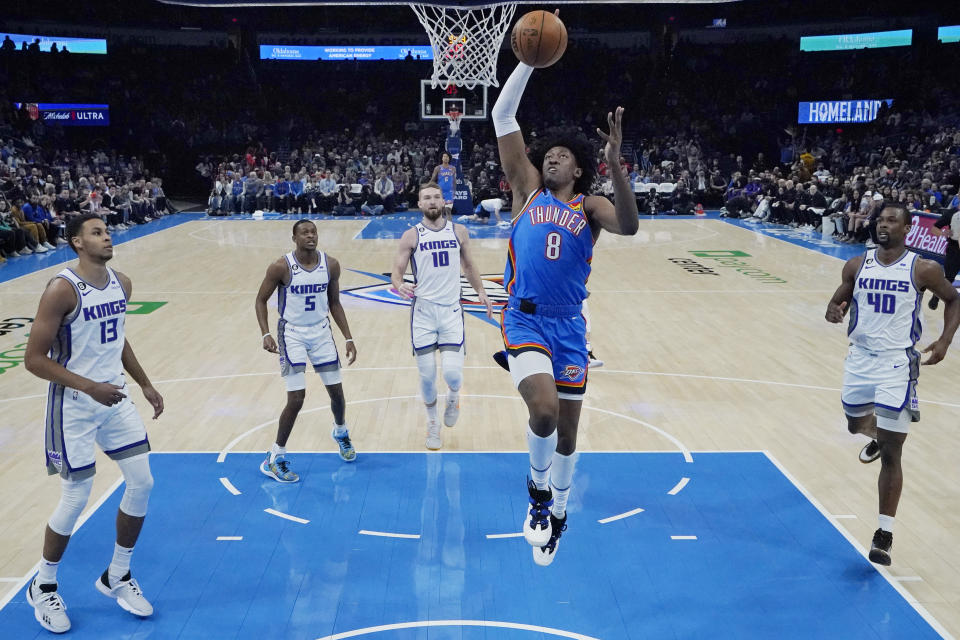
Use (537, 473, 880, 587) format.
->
(503, 188, 593, 305)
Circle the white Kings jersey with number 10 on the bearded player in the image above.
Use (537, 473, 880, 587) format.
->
(411, 220, 460, 305)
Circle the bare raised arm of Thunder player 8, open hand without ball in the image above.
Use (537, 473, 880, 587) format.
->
(584, 107, 640, 238)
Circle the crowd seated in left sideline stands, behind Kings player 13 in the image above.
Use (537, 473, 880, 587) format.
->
(0, 137, 172, 261)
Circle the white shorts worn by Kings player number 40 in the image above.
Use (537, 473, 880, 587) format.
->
(841, 345, 920, 432)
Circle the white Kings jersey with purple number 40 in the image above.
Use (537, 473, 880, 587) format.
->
(847, 249, 923, 351)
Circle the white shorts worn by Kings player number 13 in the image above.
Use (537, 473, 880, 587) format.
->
(44, 375, 150, 480)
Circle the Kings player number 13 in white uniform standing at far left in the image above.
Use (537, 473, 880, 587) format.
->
(24, 213, 163, 633)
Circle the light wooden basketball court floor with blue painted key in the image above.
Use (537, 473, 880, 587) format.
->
(0, 214, 960, 639)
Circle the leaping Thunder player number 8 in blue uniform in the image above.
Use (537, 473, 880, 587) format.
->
(492, 63, 639, 565)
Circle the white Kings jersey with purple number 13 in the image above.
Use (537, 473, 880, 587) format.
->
(50, 267, 127, 384)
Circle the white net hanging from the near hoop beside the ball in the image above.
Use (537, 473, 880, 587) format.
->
(410, 4, 517, 89)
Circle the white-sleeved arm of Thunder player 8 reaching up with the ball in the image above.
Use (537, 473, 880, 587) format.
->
(490, 62, 541, 211)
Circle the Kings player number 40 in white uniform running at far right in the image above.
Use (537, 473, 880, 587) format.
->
(826, 204, 960, 565)
